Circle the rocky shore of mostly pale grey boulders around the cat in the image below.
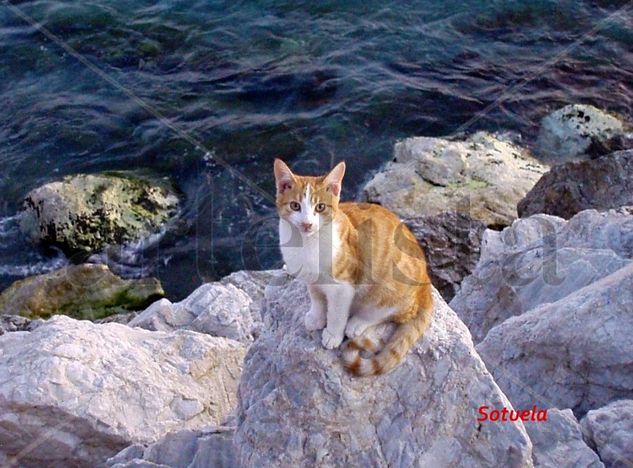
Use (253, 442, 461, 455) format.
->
(0, 106, 633, 468)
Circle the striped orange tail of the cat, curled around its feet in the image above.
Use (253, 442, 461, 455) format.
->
(343, 302, 433, 377)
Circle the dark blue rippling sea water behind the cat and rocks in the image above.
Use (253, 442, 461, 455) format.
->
(0, 0, 633, 297)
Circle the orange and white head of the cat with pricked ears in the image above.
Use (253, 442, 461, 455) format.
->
(275, 159, 345, 236)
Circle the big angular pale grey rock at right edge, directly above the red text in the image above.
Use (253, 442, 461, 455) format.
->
(477, 263, 633, 416)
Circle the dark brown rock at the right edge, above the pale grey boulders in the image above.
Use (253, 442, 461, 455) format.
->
(518, 150, 633, 218)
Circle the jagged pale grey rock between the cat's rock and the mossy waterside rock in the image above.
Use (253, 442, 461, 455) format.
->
(128, 271, 273, 343)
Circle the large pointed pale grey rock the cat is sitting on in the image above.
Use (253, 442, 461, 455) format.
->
(234, 272, 531, 467)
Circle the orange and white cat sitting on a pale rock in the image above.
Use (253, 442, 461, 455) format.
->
(274, 159, 433, 376)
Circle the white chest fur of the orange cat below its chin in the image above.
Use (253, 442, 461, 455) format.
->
(279, 219, 340, 284)
